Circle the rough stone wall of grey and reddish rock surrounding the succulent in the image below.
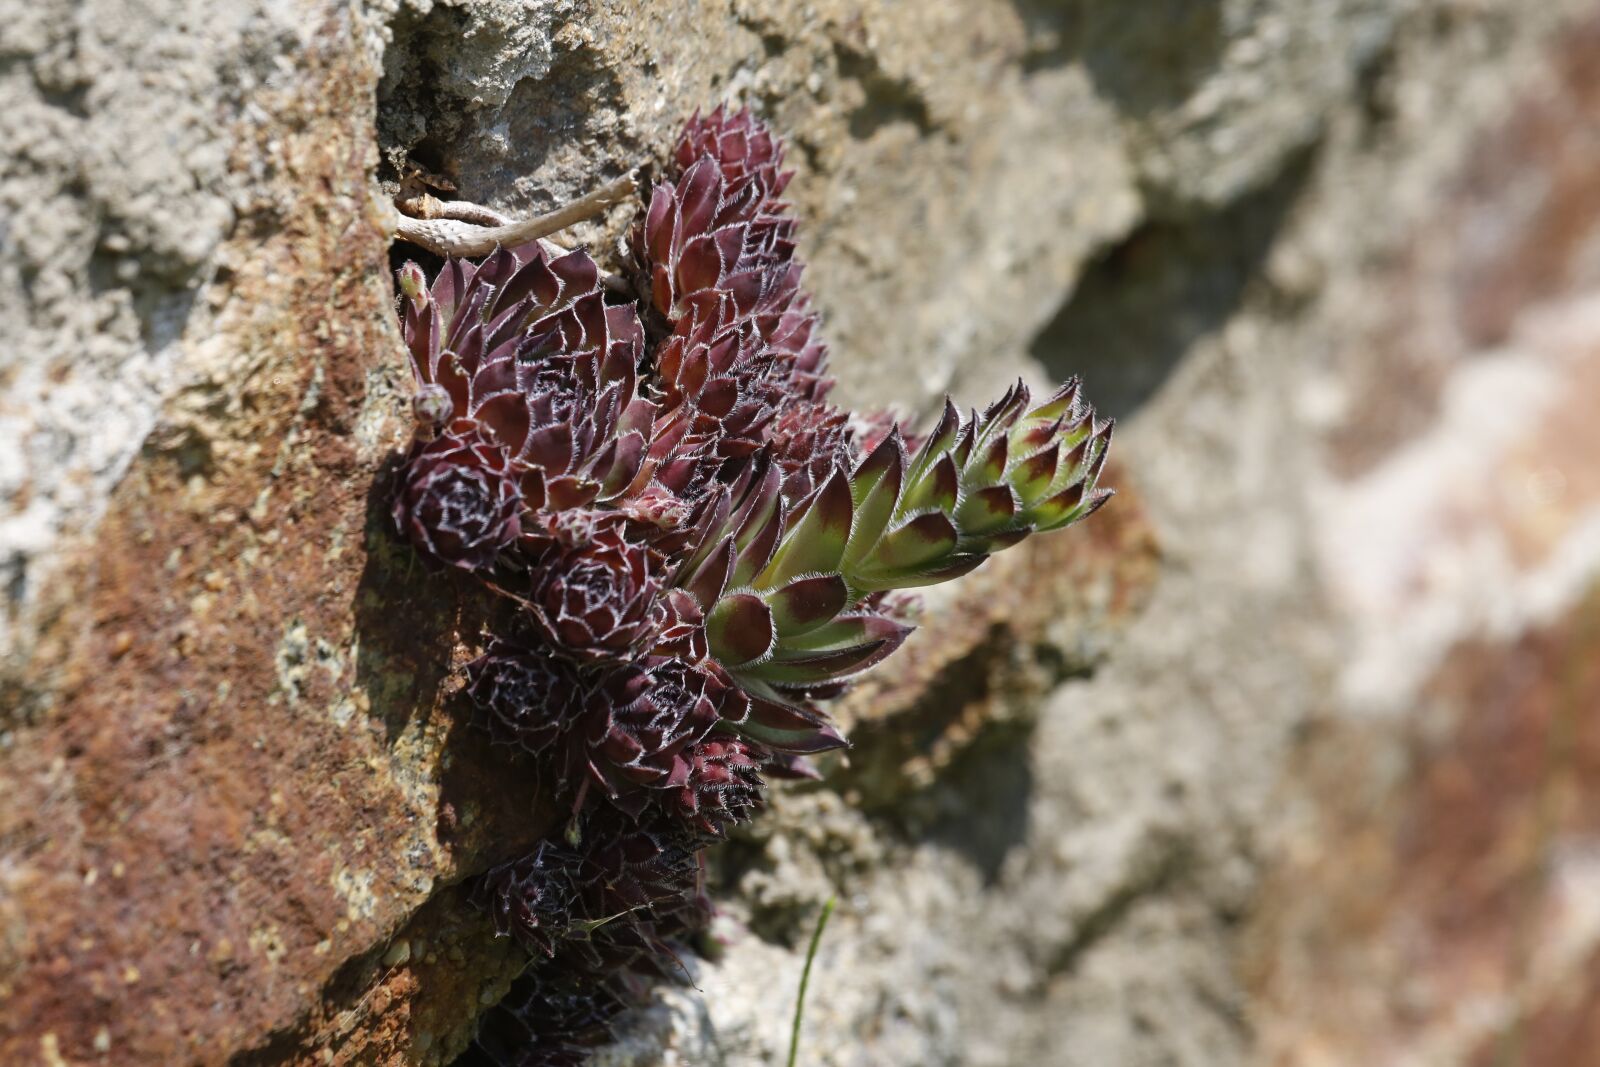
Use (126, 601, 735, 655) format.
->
(0, 0, 1600, 1067)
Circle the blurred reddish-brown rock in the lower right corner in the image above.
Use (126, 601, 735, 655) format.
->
(1254, 589, 1600, 1067)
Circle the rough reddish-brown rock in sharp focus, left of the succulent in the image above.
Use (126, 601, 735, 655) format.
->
(0, 27, 556, 1064)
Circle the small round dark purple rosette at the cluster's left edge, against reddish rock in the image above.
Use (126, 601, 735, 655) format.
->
(392, 426, 523, 571)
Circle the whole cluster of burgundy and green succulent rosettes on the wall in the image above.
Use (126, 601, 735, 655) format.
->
(394, 109, 1112, 1062)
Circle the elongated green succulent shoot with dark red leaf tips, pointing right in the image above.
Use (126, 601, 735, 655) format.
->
(674, 381, 1112, 752)
